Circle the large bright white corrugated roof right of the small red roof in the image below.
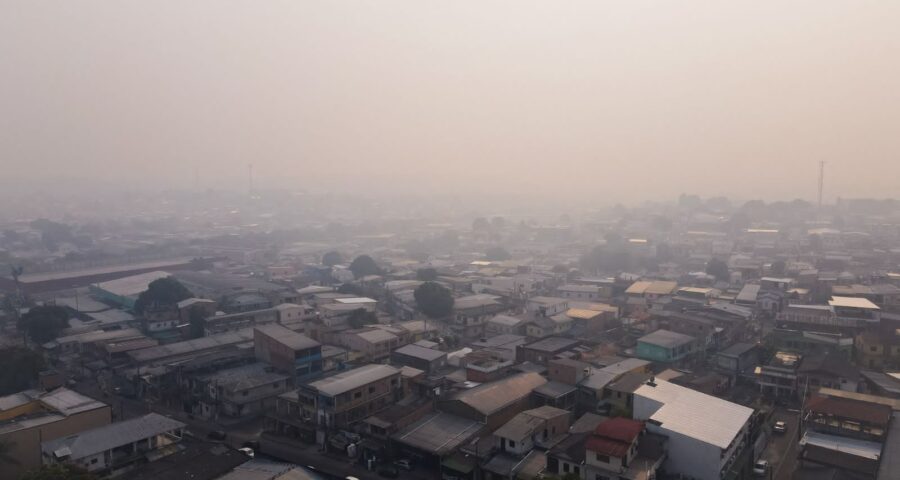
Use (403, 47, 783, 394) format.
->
(634, 379, 753, 448)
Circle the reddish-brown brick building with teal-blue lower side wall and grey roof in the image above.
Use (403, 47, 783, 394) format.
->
(253, 324, 322, 383)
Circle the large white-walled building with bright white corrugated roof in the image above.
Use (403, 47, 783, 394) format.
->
(633, 379, 753, 480)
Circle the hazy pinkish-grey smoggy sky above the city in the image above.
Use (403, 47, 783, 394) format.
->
(0, 0, 900, 202)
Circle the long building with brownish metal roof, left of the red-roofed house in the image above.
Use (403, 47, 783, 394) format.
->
(438, 372, 547, 430)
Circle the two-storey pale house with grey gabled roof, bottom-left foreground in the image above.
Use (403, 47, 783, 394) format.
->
(41, 413, 186, 473)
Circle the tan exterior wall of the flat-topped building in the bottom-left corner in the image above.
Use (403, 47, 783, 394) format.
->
(0, 406, 112, 478)
